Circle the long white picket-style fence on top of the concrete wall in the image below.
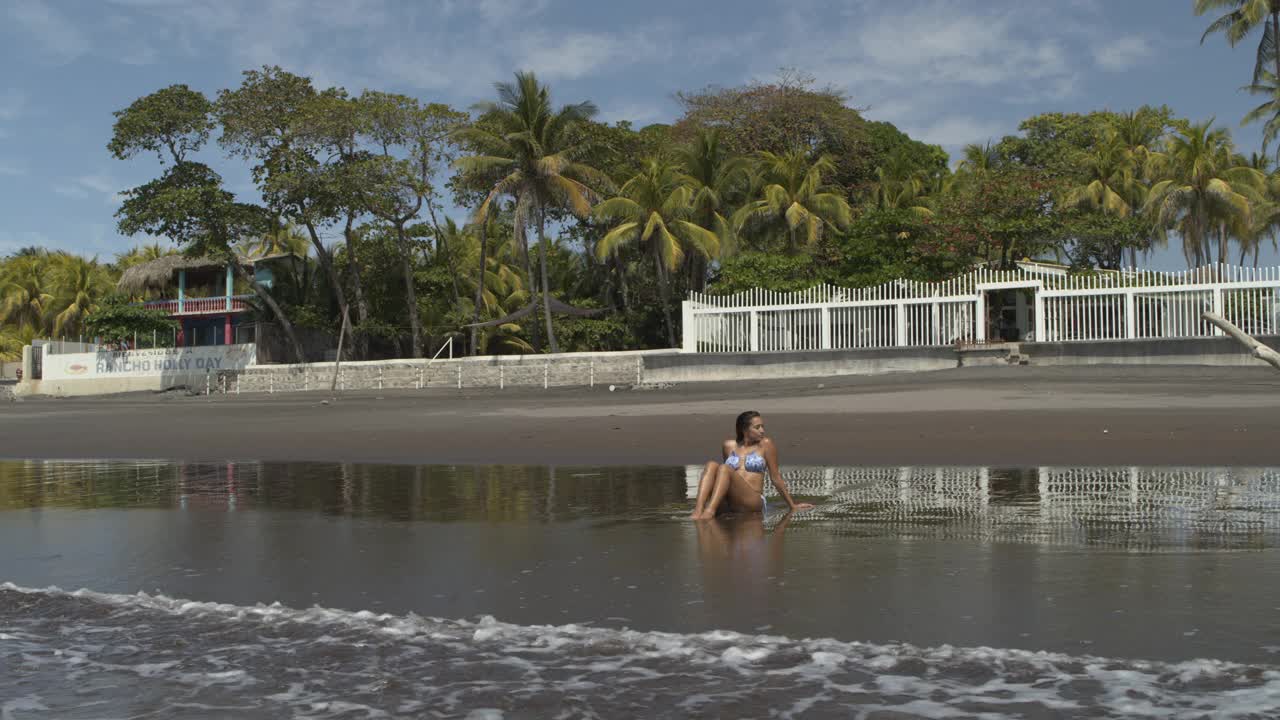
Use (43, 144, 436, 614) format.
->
(684, 263, 1280, 352)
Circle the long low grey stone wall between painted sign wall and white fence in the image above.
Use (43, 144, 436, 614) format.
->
(225, 350, 676, 393)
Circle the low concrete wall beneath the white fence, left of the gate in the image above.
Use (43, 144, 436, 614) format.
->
(644, 346, 957, 383)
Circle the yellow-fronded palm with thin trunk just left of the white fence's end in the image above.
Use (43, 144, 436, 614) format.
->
(595, 158, 719, 347)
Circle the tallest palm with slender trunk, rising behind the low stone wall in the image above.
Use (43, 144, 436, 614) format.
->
(456, 72, 609, 352)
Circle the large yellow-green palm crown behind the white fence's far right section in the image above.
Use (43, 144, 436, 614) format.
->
(1146, 119, 1266, 265)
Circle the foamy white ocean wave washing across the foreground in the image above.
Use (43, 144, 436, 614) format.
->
(0, 583, 1280, 720)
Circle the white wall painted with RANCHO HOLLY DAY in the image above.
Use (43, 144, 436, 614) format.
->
(44, 343, 257, 380)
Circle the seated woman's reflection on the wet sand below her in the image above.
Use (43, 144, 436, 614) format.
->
(696, 512, 791, 622)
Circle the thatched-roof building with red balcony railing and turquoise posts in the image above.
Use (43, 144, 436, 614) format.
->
(116, 255, 294, 347)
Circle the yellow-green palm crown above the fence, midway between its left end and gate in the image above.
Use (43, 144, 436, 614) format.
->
(733, 150, 852, 252)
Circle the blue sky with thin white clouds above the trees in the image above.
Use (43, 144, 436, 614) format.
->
(0, 0, 1280, 269)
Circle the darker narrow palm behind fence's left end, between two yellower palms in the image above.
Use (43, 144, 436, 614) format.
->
(676, 128, 750, 286)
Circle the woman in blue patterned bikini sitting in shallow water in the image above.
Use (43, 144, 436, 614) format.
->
(692, 410, 813, 520)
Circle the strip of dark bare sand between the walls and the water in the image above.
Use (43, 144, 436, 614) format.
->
(0, 366, 1280, 466)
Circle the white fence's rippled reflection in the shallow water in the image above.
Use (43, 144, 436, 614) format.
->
(689, 466, 1280, 547)
